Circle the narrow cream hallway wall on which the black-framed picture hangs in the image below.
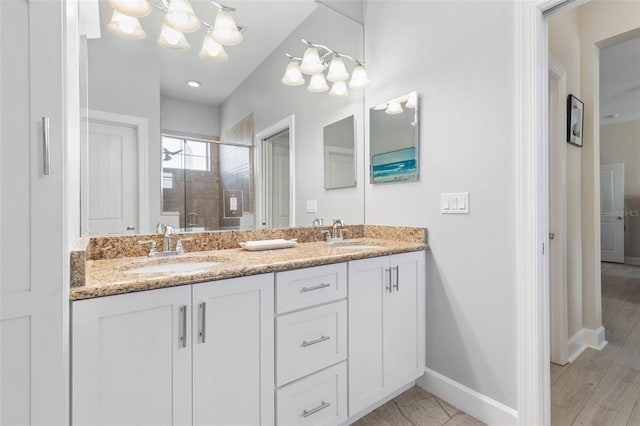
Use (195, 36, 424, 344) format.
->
(549, 9, 582, 337)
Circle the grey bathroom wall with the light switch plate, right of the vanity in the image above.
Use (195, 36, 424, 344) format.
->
(365, 1, 518, 408)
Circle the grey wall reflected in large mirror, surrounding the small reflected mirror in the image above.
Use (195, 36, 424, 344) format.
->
(220, 6, 364, 225)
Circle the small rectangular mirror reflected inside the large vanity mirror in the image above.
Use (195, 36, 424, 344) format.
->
(323, 115, 357, 189)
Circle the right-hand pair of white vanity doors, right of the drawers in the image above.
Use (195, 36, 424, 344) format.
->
(348, 251, 426, 416)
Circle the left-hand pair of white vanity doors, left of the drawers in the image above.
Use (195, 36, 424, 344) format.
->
(72, 274, 274, 426)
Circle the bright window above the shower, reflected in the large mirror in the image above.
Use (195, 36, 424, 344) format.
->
(162, 135, 211, 172)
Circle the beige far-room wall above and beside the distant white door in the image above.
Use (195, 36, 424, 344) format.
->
(600, 120, 640, 260)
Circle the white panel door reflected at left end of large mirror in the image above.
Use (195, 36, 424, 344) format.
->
(87, 120, 139, 235)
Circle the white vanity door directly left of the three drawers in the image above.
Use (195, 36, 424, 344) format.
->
(193, 274, 274, 426)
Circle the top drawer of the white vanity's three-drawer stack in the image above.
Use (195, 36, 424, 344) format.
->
(276, 263, 347, 314)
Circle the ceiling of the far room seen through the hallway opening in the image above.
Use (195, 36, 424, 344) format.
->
(600, 38, 640, 124)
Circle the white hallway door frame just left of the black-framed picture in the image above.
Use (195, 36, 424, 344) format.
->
(549, 55, 570, 365)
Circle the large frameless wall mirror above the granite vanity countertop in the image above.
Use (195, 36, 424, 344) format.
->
(81, 0, 365, 235)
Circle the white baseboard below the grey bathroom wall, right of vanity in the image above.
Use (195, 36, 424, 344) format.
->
(416, 368, 518, 425)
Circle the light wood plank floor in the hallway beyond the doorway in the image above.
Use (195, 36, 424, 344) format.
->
(551, 263, 640, 426)
